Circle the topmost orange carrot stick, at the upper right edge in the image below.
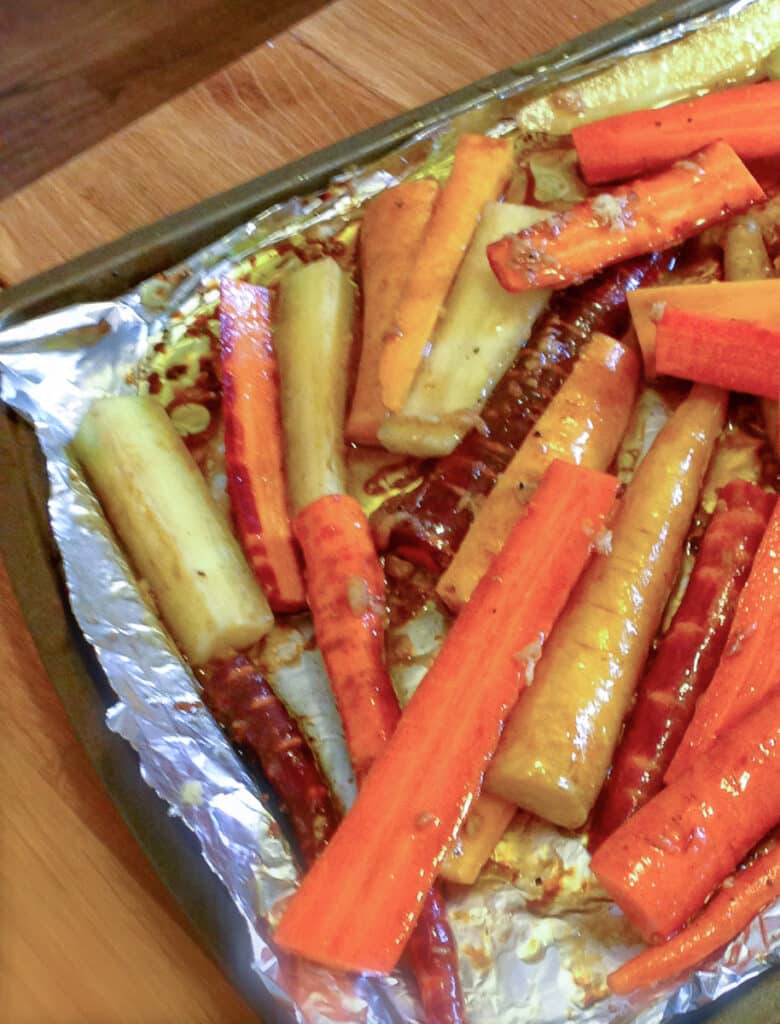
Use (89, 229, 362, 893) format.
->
(571, 82, 780, 184)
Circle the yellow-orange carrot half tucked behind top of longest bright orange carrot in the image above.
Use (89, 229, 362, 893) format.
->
(436, 334, 640, 609)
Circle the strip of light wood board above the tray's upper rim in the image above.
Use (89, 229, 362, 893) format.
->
(0, 0, 640, 283)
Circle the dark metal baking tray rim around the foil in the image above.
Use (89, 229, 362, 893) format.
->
(0, 0, 780, 1024)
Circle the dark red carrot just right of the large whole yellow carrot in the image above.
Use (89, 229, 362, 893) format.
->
(589, 480, 775, 849)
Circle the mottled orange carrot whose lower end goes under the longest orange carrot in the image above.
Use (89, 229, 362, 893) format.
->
(293, 495, 400, 780)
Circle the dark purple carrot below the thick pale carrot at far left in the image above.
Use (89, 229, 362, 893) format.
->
(203, 655, 339, 864)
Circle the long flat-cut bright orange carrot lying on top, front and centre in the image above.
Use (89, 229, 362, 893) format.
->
(276, 462, 616, 972)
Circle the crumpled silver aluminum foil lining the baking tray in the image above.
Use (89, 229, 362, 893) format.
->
(0, 0, 780, 1024)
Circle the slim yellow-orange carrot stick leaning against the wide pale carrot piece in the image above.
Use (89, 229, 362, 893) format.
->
(380, 135, 512, 413)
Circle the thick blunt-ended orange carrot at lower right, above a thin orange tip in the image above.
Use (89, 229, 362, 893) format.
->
(591, 691, 780, 941)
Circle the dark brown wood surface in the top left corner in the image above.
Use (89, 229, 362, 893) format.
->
(0, 0, 326, 197)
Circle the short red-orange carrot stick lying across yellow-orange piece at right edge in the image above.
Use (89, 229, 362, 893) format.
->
(655, 306, 780, 398)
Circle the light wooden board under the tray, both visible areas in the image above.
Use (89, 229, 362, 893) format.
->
(12, 0, 772, 1024)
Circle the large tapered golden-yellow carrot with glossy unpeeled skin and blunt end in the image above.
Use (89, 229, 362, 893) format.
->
(485, 385, 726, 828)
